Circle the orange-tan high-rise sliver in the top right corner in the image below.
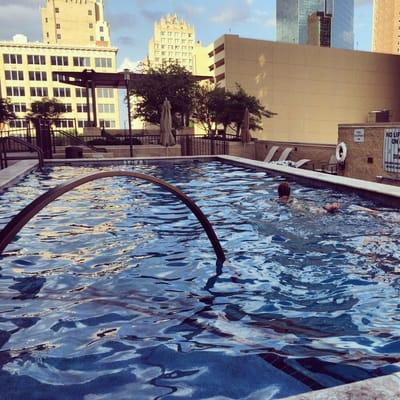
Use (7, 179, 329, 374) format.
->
(372, 0, 400, 54)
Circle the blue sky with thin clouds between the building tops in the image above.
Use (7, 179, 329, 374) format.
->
(0, 0, 372, 71)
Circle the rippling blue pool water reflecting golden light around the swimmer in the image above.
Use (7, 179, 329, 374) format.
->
(0, 162, 400, 400)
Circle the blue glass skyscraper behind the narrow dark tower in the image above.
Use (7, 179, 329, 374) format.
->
(276, 0, 354, 49)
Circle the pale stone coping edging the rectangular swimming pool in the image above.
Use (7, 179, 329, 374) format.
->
(0, 156, 400, 400)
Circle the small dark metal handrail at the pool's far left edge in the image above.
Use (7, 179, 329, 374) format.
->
(0, 136, 44, 169)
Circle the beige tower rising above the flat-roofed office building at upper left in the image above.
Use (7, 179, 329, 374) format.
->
(41, 0, 110, 47)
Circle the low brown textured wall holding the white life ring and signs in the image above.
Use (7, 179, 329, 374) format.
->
(339, 123, 400, 184)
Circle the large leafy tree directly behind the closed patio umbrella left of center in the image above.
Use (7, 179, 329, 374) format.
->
(130, 64, 198, 128)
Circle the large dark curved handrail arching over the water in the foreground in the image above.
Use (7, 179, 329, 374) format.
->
(0, 171, 225, 262)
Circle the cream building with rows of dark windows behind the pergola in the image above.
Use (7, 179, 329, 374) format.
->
(0, 35, 119, 132)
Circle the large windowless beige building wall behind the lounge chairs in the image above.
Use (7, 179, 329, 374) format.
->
(210, 35, 400, 144)
